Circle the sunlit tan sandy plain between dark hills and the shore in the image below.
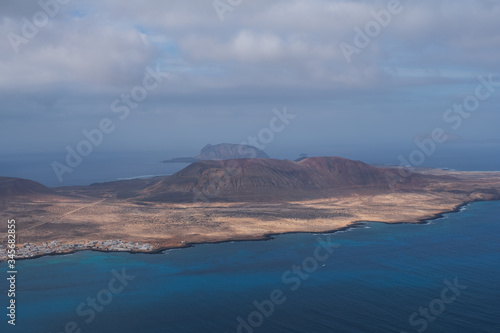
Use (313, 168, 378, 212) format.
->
(0, 169, 500, 251)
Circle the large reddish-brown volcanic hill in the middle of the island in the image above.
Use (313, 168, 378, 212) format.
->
(141, 157, 426, 202)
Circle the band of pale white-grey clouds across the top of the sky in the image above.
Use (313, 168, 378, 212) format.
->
(0, 0, 500, 101)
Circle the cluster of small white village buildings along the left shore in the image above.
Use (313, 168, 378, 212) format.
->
(0, 239, 154, 261)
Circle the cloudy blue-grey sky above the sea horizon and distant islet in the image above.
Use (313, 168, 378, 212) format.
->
(0, 0, 500, 157)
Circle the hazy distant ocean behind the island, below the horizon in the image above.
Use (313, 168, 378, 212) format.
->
(0, 143, 500, 187)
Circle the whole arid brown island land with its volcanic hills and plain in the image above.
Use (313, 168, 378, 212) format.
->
(0, 158, 500, 256)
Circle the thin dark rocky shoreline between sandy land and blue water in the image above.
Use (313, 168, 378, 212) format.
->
(0, 199, 490, 263)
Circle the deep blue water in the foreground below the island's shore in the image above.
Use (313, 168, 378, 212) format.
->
(0, 198, 500, 333)
